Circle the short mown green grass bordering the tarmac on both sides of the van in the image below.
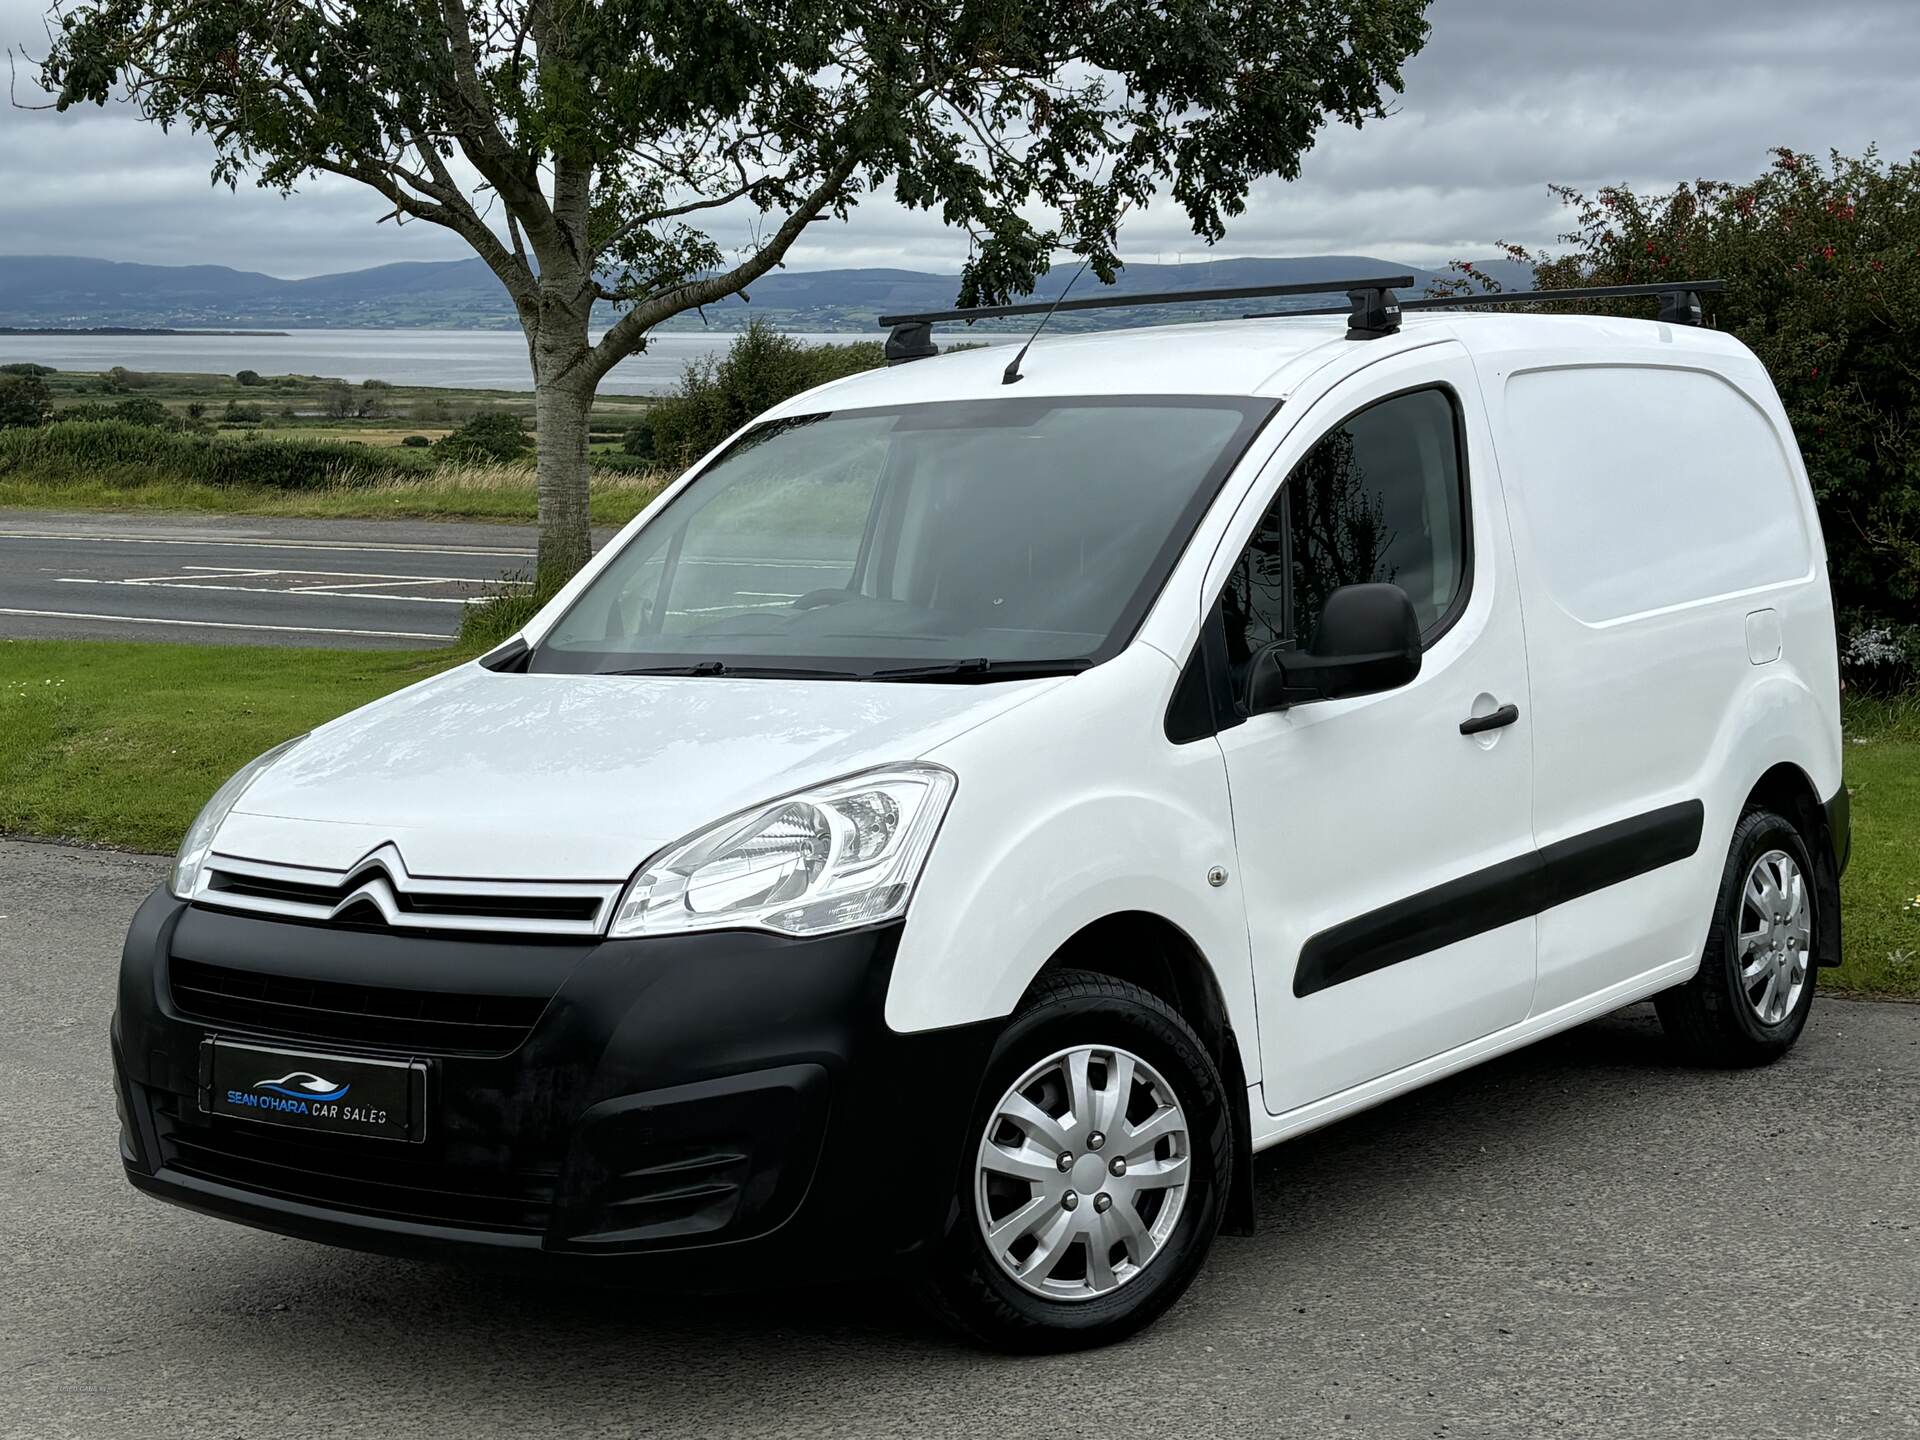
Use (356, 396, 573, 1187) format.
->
(0, 639, 1920, 996)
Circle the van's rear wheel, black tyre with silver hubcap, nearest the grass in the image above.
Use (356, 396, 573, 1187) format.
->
(1653, 810, 1822, 1066)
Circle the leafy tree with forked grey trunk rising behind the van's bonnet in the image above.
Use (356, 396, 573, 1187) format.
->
(40, 0, 1427, 576)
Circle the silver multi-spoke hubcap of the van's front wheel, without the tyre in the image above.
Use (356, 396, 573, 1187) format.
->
(973, 1044, 1192, 1300)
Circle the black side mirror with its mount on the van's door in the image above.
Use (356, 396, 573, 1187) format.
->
(1246, 586, 1421, 714)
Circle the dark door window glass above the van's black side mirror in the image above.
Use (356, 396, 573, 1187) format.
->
(1221, 390, 1469, 668)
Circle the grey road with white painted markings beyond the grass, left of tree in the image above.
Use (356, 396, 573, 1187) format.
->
(0, 511, 564, 649)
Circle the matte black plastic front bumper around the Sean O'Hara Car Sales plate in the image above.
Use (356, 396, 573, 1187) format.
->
(113, 891, 996, 1288)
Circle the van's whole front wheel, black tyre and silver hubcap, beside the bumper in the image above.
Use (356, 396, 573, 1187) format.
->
(922, 972, 1244, 1352)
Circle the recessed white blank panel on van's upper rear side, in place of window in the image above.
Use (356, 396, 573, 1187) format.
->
(1501, 365, 1812, 624)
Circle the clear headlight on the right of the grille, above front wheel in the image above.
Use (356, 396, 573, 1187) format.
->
(611, 764, 954, 937)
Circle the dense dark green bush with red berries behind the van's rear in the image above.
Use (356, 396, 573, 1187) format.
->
(1455, 150, 1920, 684)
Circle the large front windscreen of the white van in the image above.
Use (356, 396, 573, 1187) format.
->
(530, 396, 1275, 680)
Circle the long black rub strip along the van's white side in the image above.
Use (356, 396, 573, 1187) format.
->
(1294, 801, 1707, 995)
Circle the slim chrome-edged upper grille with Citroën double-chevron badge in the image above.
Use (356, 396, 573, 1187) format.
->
(194, 845, 620, 937)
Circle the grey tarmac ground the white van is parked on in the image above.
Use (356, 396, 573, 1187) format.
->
(0, 841, 1920, 1440)
